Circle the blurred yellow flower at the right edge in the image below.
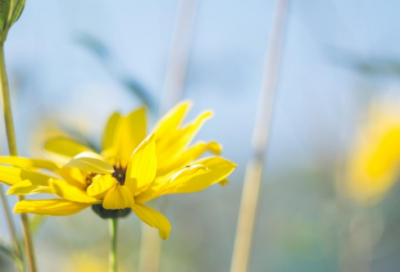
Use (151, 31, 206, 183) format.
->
(347, 102, 400, 204)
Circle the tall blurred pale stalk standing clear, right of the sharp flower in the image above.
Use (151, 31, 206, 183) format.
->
(231, 0, 289, 272)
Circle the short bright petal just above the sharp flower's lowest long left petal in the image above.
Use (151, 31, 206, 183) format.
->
(50, 180, 101, 204)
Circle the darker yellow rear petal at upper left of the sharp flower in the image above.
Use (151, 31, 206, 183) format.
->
(44, 138, 95, 160)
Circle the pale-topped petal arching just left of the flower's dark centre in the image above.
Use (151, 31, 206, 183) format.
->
(63, 152, 114, 175)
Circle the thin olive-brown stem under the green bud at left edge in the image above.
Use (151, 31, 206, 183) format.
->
(0, 43, 37, 272)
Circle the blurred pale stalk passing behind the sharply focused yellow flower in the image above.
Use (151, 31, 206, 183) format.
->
(139, 0, 198, 272)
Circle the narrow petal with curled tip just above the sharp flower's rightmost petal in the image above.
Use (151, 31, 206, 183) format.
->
(157, 141, 222, 176)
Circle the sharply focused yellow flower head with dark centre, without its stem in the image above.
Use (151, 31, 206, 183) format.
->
(0, 103, 236, 239)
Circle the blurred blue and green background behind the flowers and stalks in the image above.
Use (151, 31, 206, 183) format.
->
(0, 0, 400, 272)
